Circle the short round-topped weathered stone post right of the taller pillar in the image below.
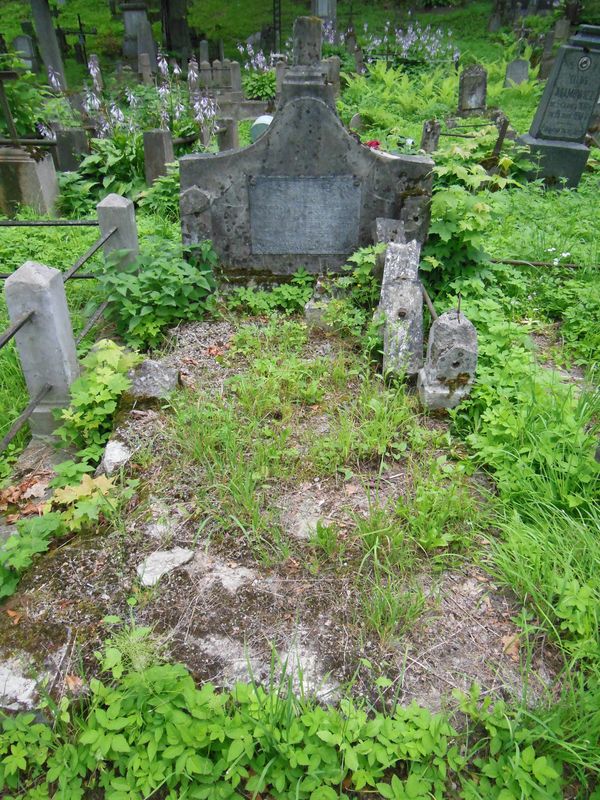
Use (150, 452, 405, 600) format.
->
(417, 310, 477, 411)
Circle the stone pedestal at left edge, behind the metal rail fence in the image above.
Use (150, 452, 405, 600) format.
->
(0, 147, 58, 216)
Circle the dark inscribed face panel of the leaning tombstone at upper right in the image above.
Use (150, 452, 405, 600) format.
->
(530, 45, 600, 142)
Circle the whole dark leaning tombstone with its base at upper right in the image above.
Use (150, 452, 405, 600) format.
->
(520, 25, 600, 187)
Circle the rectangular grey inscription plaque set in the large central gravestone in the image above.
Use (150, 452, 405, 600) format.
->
(248, 175, 362, 255)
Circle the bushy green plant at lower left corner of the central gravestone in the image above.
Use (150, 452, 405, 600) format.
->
(100, 237, 217, 348)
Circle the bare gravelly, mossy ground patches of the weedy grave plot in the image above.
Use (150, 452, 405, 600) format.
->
(0, 322, 558, 710)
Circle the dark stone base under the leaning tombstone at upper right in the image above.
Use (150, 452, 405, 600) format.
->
(519, 133, 590, 188)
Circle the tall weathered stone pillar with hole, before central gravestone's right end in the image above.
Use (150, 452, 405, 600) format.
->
(378, 240, 423, 376)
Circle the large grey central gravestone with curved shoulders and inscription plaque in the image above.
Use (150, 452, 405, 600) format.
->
(180, 17, 433, 277)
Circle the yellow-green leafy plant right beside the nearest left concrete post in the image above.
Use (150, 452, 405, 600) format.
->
(56, 339, 138, 462)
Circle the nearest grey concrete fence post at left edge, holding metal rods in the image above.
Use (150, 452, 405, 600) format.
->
(4, 261, 79, 437)
